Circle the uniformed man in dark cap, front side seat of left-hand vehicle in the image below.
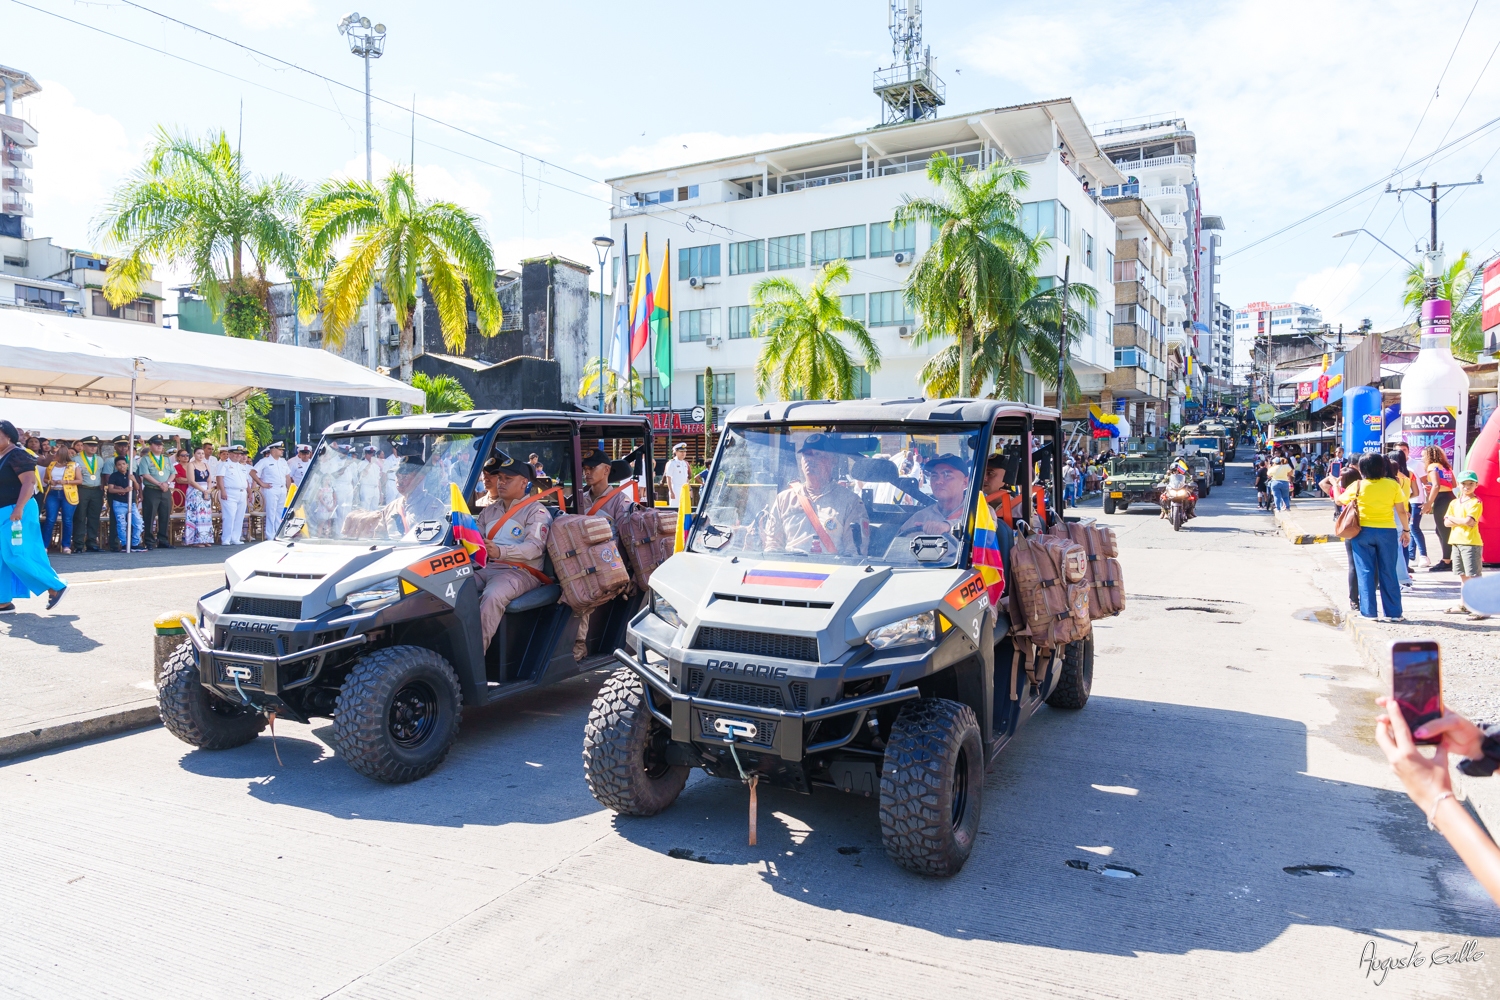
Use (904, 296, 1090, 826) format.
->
(474, 454, 552, 651)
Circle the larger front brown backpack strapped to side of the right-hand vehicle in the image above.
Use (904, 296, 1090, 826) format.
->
(1010, 532, 1094, 649)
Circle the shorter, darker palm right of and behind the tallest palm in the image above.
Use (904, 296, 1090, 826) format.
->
(918, 279, 1098, 405)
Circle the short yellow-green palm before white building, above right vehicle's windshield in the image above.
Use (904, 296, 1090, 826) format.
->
(750, 261, 881, 399)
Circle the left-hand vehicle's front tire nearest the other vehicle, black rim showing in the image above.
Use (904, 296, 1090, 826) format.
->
(333, 646, 464, 784)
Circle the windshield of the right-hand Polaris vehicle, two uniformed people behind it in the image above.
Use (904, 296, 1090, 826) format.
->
(689, 424, 980, 567)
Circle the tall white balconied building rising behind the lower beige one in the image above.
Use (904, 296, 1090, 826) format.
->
(1097, 118, 1212, 423)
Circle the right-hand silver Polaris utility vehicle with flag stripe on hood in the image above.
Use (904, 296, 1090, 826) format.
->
(584, 399, 1094, 876)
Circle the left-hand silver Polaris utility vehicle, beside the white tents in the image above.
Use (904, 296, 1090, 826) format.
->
(158, 411, 651, 781)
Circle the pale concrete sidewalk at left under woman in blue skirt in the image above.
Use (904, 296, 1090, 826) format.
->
(0, 546, 227, 760)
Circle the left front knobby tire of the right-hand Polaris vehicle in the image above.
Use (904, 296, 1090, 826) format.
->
(584, 667, 690, 816)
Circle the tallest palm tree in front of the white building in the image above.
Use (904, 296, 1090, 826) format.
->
(891, 153, 1047, 385)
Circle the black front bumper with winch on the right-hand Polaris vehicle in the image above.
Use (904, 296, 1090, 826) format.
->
(615, 649, 921, 763)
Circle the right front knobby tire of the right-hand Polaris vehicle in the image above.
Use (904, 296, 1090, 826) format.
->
(881, 699, 984, 876)
